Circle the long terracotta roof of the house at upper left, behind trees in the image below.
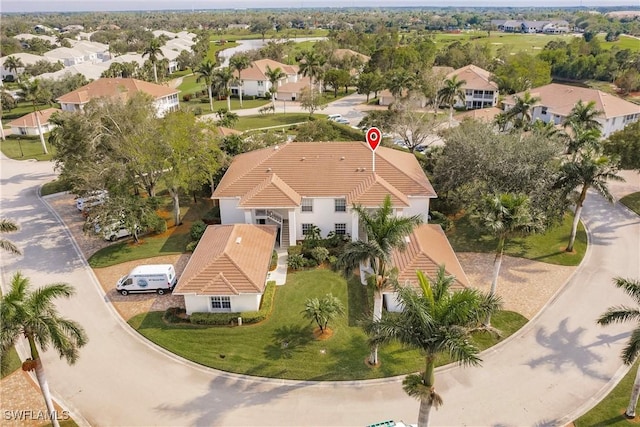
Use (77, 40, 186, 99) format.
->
(57, 78, 178, 104)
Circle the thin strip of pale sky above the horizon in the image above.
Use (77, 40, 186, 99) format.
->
(0, 0, 640, 13)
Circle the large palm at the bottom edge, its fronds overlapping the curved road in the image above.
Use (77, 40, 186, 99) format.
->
(366, 266, 500, 427)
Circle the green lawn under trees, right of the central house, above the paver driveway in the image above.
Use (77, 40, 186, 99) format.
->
(447, 215, 587, 266)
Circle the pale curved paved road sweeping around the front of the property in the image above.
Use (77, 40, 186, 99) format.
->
(0, 154, 640, 426)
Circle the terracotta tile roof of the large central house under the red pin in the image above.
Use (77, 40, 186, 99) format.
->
(213, 142, 436, 207)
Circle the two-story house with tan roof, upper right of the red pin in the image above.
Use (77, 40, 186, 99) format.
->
(446, 65, 498, 110)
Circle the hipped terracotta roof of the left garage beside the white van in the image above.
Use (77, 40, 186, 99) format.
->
(173, 224, 277, 295)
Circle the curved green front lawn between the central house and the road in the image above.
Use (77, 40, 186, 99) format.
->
(129, 269, 526, 380)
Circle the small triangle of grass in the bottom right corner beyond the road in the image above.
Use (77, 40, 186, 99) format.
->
(573, 362, 640, 427)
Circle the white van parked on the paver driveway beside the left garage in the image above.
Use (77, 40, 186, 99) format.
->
(116, 264, 178, 295)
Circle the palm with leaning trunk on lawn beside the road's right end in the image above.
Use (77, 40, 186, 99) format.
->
(556, 150, 624, 252)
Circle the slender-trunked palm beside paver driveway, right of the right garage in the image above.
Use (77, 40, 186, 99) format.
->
(472, 193, 541, 326)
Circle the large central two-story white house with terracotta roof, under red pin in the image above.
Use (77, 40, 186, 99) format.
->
(212, 142, 436, 247)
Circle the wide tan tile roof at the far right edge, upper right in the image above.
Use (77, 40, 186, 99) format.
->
(503, 83, 640, 119)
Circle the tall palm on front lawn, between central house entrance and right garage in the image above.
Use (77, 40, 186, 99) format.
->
(337, 195, 422, 365)
